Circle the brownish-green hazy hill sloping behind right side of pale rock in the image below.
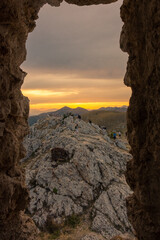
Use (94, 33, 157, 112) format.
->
(82, 110, 126, 132)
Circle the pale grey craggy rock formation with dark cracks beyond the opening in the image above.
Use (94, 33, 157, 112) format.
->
(23, 116, 132, 239)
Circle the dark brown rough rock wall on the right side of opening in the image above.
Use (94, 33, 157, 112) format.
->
(121, 0, 160, 240)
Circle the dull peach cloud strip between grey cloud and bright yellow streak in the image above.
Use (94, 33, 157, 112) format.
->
(23, 70, 123, 90)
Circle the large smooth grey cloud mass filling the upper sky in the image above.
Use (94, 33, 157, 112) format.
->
(23, 1, 127, 78)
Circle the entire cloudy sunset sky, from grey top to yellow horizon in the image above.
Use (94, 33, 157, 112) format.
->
(22, 0, 130, 114)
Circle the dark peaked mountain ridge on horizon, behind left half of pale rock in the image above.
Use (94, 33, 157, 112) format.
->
(28, 106, 88, 126)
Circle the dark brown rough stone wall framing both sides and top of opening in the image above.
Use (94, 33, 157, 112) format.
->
(0, 0, 160, 240)
